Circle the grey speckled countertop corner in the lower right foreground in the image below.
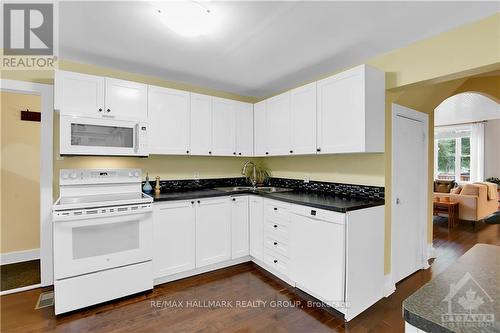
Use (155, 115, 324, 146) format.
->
(403, 244, 500, 333)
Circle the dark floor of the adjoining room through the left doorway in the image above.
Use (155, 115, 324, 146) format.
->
(0, 260, 40, 291)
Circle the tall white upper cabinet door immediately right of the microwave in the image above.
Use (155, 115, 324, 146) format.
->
(148, 86, 190, 155)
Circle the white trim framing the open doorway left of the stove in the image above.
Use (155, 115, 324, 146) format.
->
(0, 79, 54, 286)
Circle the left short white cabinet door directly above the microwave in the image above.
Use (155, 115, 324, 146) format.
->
(54, 70, 106, 118)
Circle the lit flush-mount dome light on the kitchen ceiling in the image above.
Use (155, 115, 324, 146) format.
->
(154, 0, 218, 37)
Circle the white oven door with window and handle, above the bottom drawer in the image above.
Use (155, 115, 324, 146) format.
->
(54, 211, 153, 280)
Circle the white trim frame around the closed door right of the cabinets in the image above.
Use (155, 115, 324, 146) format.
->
(390, 103, 429, 284)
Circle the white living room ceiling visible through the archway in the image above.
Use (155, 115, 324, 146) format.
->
(434, 93, 500, 126)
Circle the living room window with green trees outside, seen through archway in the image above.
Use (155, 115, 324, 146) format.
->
(434, 126, 471, 182)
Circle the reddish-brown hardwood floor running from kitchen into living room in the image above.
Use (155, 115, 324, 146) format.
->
(0, 219, 500, 333)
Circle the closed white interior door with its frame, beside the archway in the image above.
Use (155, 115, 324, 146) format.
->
(392, 104, 428, 283)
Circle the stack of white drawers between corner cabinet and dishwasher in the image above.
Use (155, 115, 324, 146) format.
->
(264, 199, 291, 276)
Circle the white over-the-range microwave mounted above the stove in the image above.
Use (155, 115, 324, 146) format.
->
(59, 115, 149, 156)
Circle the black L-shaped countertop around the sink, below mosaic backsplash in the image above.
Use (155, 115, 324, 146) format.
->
(153, 189, 384, 213)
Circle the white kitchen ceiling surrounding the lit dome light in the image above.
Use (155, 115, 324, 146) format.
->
(59, 1, 499, 97)
